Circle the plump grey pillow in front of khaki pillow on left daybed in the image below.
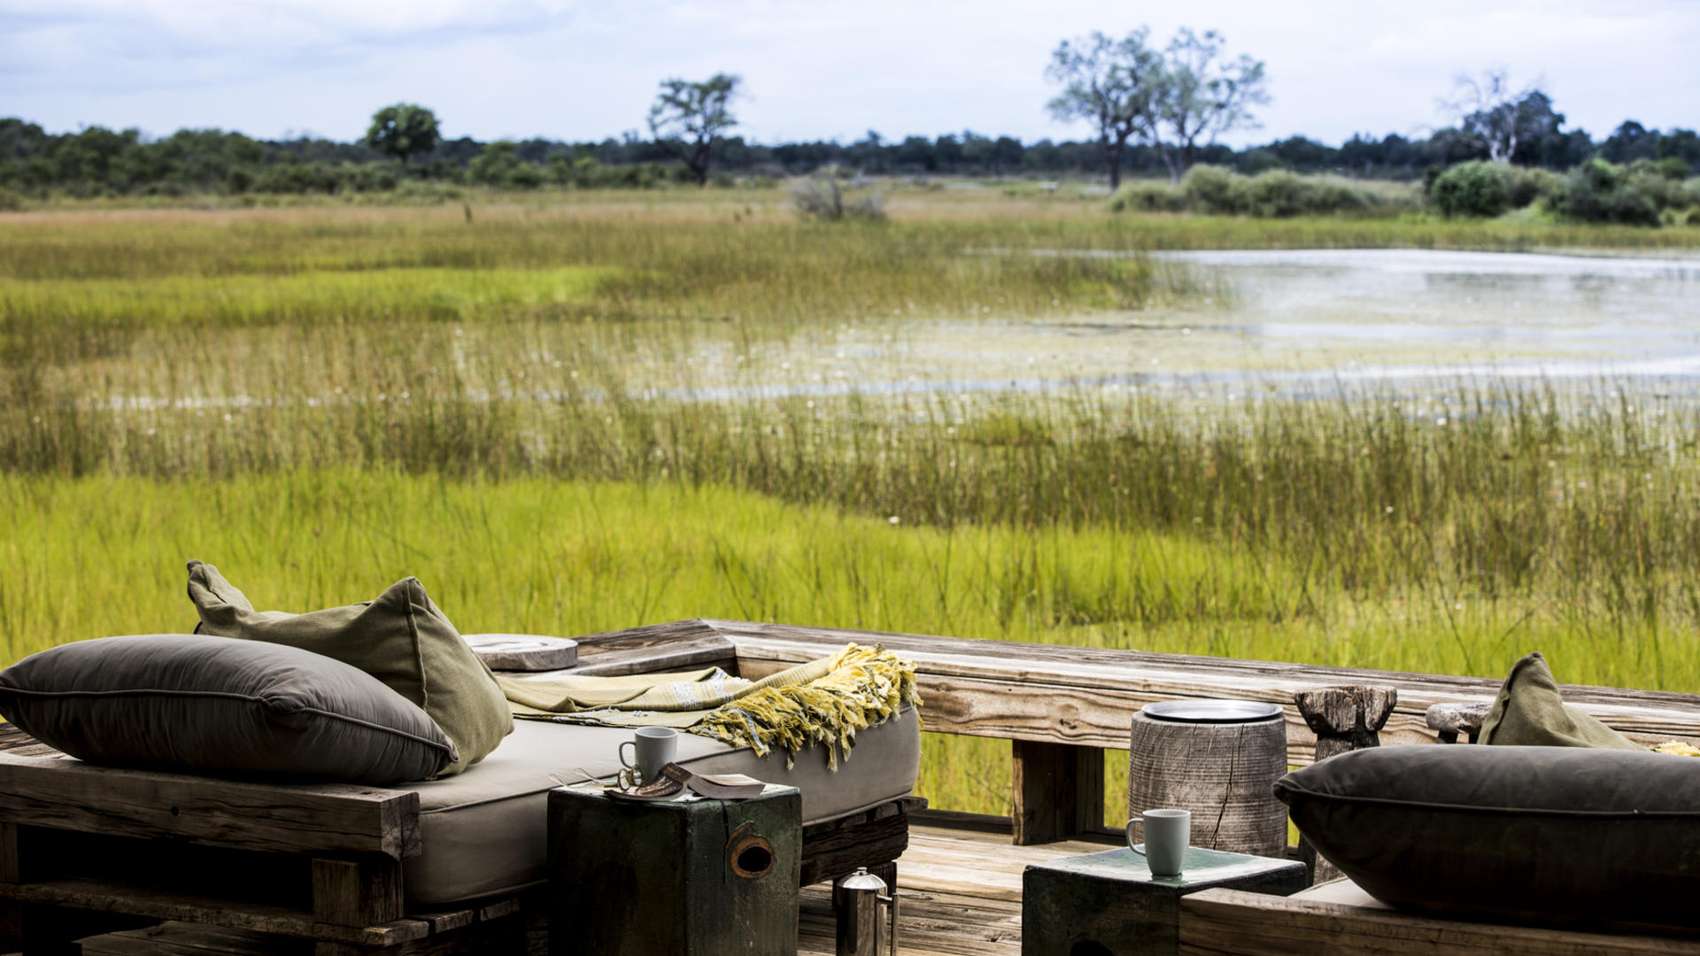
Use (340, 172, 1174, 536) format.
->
(0, 634, 454, 786)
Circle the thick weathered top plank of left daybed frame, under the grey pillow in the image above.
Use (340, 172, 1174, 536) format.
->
(0, 754, 420, 859)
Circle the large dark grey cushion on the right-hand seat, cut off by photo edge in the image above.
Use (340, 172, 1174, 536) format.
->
(1275, 745, 1700, 927)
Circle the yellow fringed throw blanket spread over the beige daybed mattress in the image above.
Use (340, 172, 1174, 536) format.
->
(496, 645, 921, 771)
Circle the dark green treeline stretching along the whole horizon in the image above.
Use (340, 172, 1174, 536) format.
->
(0, 114, 1700, 197)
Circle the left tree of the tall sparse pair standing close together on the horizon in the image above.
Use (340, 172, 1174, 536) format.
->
(1046, 27, 1163, 189)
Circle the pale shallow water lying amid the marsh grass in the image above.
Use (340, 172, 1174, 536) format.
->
(699, 250, 1700, 396)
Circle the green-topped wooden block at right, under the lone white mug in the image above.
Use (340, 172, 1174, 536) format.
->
(1022, 847, 1306, 956)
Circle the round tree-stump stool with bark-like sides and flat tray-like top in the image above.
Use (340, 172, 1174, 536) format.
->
(1127, 701, 1287, 856)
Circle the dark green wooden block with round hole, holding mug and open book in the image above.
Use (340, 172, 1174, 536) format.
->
(549, 786, 802, 956)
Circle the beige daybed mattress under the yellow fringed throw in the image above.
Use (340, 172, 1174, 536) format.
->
(405, 709, 921, 905)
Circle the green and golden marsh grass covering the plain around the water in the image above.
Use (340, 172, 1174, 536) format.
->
(0, 194, 1700, 810)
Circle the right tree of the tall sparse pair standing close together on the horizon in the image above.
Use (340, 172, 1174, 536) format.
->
(1151, 27, 1270, 182)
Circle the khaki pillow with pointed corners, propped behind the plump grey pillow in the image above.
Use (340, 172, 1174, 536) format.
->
(189, 561, 513, 776)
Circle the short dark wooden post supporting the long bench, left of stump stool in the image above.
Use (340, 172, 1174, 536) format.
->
(1010, 740, 1103, 847)
